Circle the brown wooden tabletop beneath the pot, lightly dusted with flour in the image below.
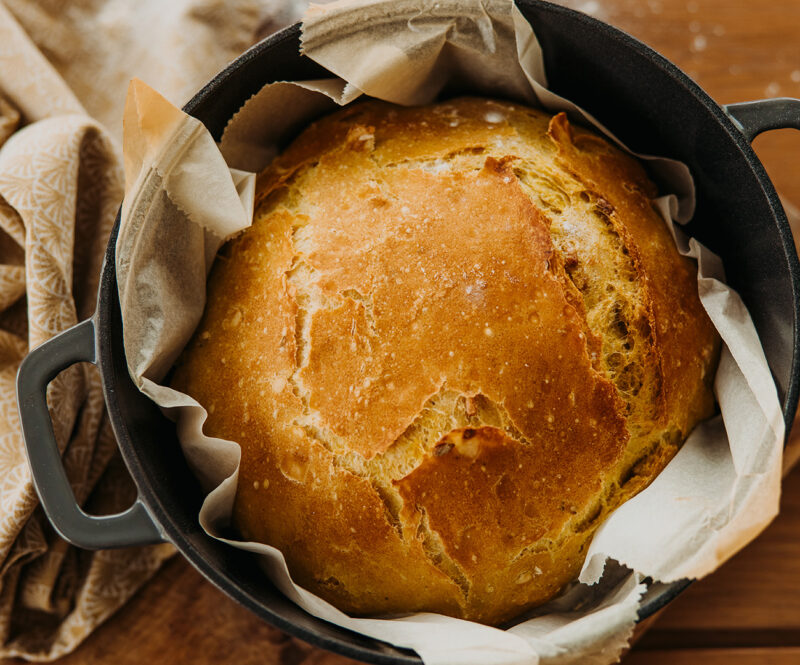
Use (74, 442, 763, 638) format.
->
(9, 0, 800, 665)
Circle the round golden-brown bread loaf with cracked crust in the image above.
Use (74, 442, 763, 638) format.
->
(174, 98, 719, 624)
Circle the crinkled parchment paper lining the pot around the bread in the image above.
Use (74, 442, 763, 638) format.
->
(117, 0, 784, 665)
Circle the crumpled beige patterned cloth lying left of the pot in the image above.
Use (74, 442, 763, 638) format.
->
(0, 0, 302, 661)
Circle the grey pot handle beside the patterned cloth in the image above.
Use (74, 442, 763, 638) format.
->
(17, 319, 165, 549)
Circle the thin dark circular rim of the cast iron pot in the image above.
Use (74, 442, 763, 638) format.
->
(95, 0, 800, 665)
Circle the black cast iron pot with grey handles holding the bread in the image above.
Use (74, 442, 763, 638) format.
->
(17, 0, 800, 664)
